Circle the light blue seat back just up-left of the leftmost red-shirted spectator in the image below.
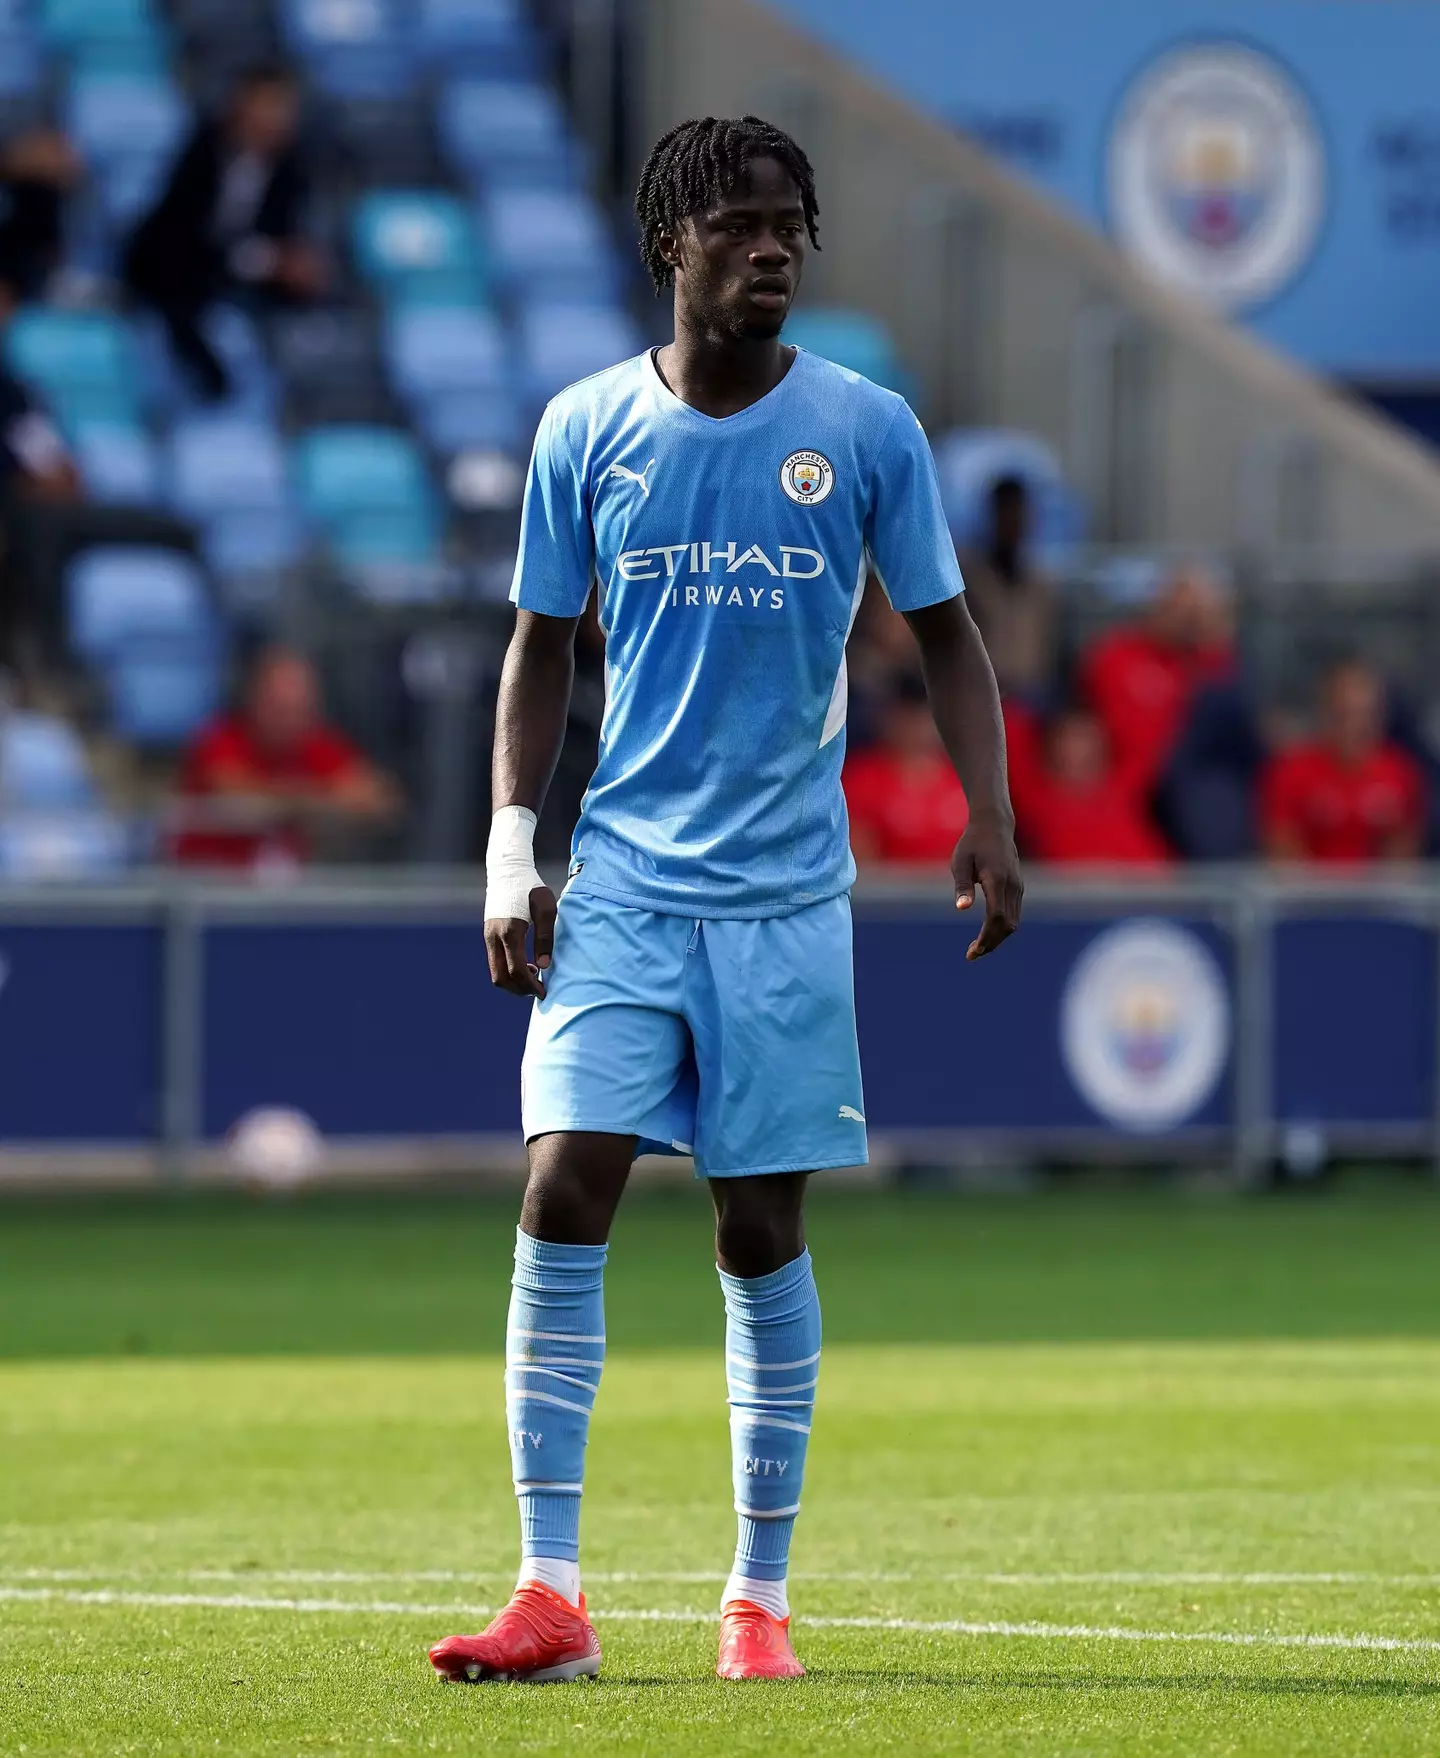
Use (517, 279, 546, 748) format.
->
(65, 547, 216, 665)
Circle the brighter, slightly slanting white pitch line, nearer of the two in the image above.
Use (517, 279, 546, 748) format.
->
(0, 1587, 1440, 1654)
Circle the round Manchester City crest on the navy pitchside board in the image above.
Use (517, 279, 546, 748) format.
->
(1060, 921, 1231, 1130)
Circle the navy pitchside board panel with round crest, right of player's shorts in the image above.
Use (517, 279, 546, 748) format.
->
(855, 912, 1234, 1136)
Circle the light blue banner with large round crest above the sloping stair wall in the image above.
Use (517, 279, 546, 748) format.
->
(772, 0, 1440, 380)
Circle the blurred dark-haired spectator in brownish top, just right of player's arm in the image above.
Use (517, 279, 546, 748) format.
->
(960, 476, 1055, 701)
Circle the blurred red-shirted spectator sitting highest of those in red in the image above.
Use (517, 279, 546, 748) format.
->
(1080, 566, 1234, 791)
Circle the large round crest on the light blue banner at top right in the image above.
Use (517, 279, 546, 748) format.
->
(1109, 44, 1326, 309)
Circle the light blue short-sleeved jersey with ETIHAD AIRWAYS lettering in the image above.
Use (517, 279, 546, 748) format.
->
(510, 350, 964, 918)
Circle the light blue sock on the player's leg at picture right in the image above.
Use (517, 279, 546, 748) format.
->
(719, 1252, 819, 1616)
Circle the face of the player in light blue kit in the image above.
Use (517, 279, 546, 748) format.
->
(673, 158, 807, 339)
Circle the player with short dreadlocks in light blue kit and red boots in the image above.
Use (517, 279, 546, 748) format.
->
(431, 116, 1020, 1681)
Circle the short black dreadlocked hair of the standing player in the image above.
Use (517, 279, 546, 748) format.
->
(635, 116, 819, 294)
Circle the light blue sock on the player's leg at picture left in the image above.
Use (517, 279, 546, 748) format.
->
(505, 1229, 607, 1563)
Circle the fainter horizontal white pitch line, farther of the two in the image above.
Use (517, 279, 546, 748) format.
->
(0, 1566, 1440, 1587)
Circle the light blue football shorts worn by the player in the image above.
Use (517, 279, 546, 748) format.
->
(520, 891, 867, 1178)
